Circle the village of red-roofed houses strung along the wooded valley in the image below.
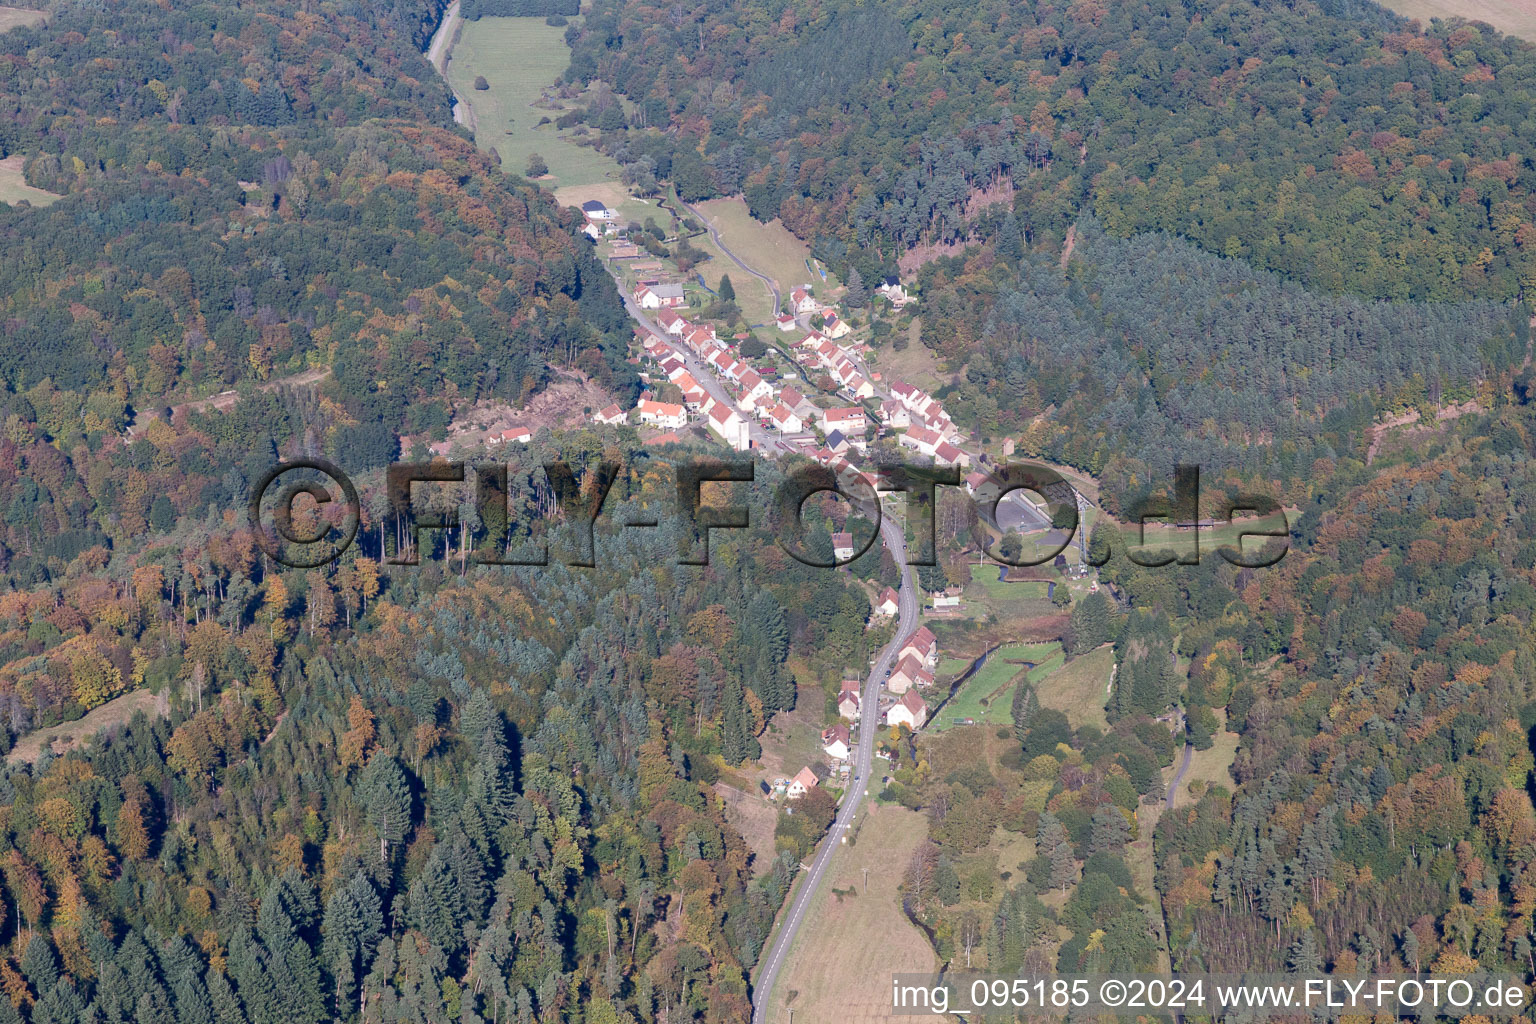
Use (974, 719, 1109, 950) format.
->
(433, 191, 1081, 808)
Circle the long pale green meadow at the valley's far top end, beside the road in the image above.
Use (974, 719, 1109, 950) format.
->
(449, 18, 619, 189)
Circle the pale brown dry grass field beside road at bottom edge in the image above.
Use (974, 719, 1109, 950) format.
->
(768, 806, 937, 1024)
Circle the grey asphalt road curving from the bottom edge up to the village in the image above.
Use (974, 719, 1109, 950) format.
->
(753, 517, 917, 1024)
